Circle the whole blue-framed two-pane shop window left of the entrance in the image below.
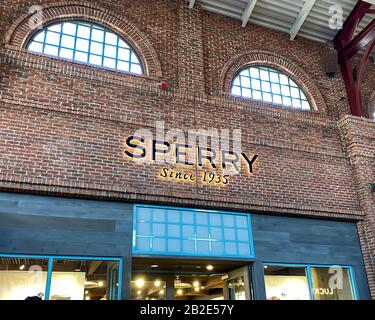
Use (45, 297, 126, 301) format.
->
(0, 255, 121, 300)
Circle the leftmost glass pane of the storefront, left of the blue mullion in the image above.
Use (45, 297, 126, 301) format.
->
(0, 257, 48, 300)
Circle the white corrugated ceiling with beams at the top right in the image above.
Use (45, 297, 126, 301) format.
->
(187, 0, 375, 42)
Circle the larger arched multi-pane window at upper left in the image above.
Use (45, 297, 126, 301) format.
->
(27, 21, 143, 75)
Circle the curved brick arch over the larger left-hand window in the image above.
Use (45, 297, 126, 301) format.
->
(5, 1, 162, 79)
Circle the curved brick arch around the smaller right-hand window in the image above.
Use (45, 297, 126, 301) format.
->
(219, 51, 327, 113)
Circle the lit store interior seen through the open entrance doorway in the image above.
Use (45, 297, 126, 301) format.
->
(131, 258, 248, 300)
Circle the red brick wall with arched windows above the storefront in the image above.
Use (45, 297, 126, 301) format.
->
(0, 0, 375, 294)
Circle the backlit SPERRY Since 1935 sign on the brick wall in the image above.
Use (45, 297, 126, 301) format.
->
(124, 122, 259, 185)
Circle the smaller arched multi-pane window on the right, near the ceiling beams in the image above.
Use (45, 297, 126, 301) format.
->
(231, 66, 311, 110)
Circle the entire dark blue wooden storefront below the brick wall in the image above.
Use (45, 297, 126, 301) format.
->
(0, 193, 370, 300)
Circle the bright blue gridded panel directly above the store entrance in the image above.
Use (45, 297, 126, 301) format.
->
(133, 205, 254, 259)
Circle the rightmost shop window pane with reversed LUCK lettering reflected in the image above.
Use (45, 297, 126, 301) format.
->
(311, 266, 354, 300)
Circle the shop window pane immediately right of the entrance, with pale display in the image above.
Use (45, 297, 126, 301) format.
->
(264, 266, 310, 300)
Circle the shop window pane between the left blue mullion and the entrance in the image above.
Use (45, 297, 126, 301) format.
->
(50, 259, 119, 300)
